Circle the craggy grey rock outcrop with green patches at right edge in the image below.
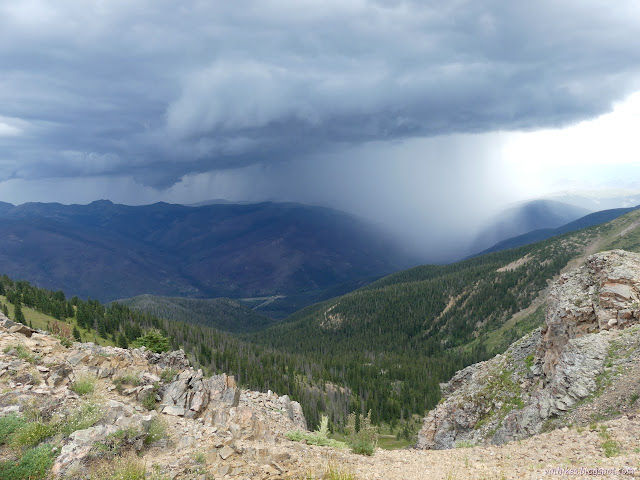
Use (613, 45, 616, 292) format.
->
(416, 250, 640, 449)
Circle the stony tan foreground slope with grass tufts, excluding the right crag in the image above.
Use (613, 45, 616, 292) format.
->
(0, 306, 640, 480)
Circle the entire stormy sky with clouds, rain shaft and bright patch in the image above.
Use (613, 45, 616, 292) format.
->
(0, 0, 640, 258)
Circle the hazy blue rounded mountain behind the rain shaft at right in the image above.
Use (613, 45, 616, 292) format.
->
(471, 200, 590, 252)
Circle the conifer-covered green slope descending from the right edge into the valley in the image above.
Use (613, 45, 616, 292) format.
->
(244, 211, 640, 421)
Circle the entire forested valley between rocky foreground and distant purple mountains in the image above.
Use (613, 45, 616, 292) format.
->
(5, 204, 640, 437)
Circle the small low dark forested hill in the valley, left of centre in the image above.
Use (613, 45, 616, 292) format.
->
(117, 295, 275, 333)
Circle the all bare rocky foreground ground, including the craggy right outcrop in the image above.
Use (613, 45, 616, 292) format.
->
(0, 252, 640, 480)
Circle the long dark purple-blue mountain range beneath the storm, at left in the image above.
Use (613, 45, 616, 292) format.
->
(0, 201, 413, 312)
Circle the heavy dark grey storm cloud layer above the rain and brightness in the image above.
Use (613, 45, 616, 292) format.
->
(0, 0, 640, 187)
